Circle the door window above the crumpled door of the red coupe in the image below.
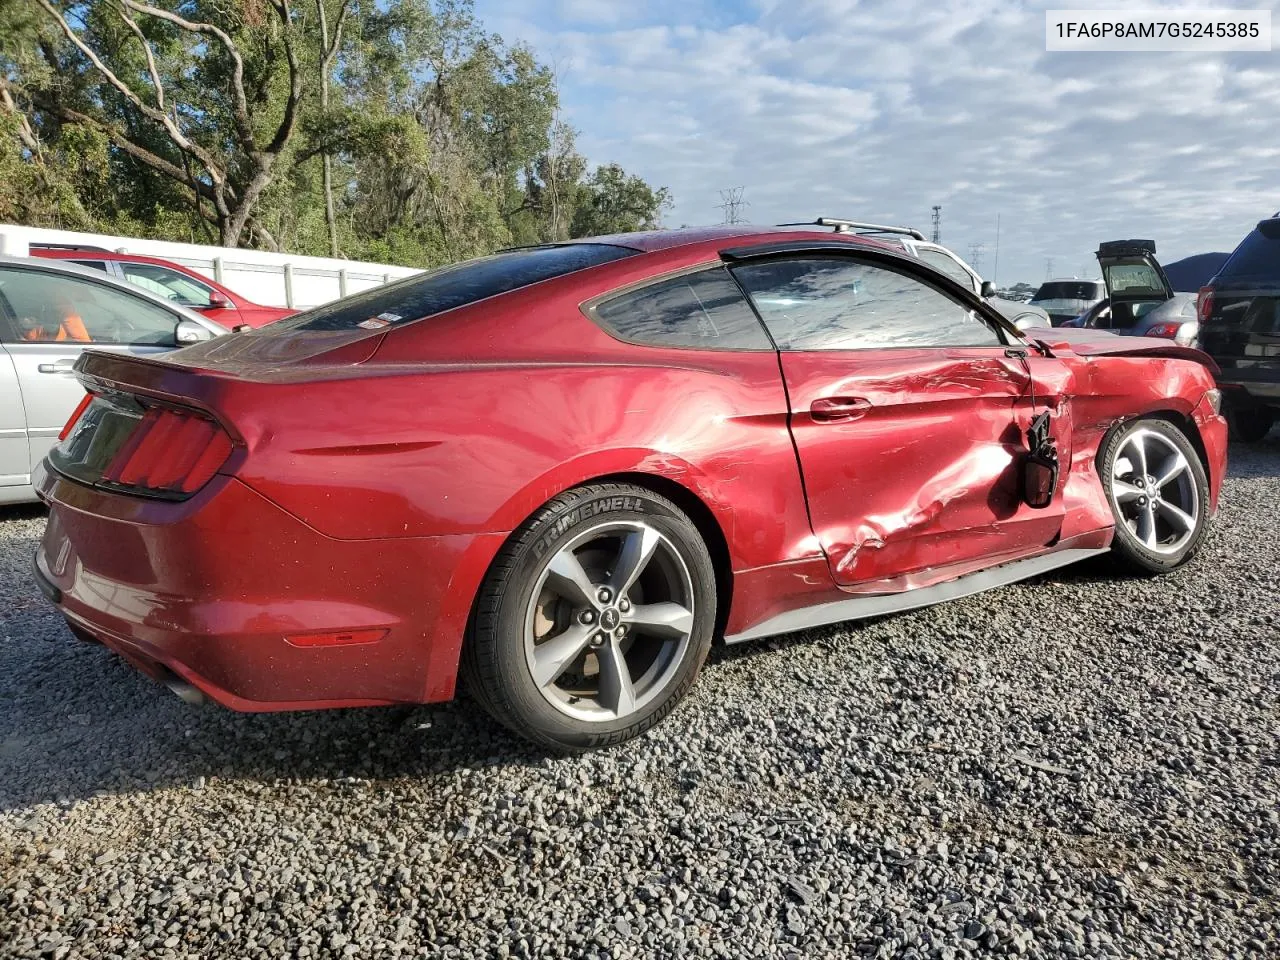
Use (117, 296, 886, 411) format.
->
(733, 257, 1002, 351)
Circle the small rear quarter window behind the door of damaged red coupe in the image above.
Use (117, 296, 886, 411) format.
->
(590, 268, 773, 349)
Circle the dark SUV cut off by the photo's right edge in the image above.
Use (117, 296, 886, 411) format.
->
(1196, 214, 1280, 443)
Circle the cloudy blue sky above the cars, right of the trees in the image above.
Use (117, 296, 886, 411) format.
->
(476, 0, 1280, 284)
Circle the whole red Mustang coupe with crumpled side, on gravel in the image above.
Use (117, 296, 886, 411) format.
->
(35, 227, 1226, 750)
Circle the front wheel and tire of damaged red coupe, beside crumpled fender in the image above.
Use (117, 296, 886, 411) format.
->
(1098, 420, 1208, 573)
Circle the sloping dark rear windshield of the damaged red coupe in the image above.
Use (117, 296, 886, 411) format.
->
(271, 243, 640, 334)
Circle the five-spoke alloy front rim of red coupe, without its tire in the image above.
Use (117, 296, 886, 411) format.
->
(1111, 429, 1201, 554)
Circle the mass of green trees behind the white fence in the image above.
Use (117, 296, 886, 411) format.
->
(0, 0, 671, 266)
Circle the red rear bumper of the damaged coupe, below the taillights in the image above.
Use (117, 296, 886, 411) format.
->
(27, 467, 504, 710)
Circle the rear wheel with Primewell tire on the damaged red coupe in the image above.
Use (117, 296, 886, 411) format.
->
(462, 484, 716, 753)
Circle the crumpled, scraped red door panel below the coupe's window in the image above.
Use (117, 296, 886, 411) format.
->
(782, 347, 1070, 586)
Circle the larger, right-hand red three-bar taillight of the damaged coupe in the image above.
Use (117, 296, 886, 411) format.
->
(102, 407, 232, 495)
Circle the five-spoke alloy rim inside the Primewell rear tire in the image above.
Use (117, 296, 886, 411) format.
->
(525, 520, 695, 722)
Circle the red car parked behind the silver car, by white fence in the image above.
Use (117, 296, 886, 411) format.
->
(31, 247, 298, 329)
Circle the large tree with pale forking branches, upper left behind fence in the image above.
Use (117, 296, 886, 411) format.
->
(6, 0, 302, 246)
